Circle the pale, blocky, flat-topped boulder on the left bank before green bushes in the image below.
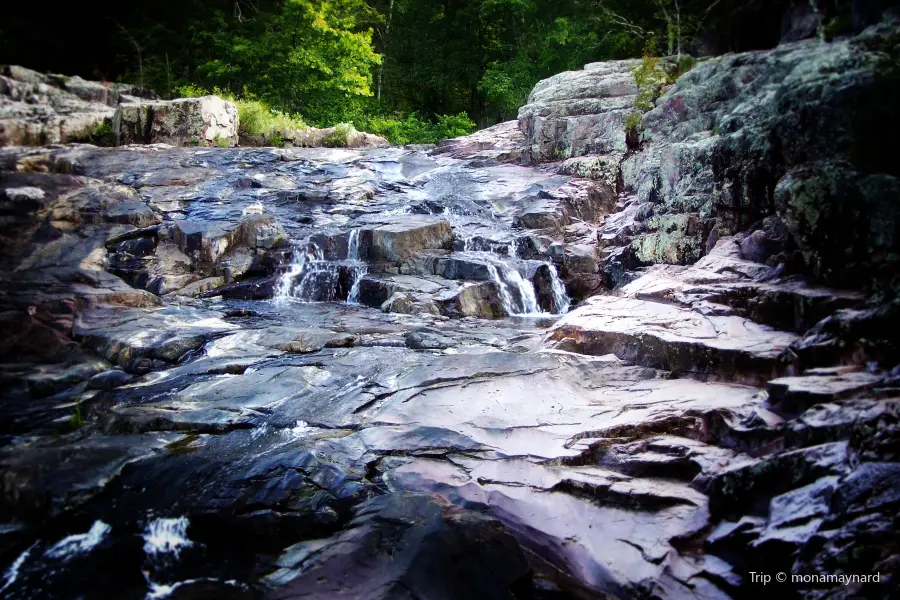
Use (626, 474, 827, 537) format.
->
(113, 96, 238, 147)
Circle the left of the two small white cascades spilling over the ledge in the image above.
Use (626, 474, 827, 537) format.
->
(274, 229, 366, 303)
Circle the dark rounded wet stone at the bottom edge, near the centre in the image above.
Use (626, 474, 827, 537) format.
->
(266, 494, 530, 600)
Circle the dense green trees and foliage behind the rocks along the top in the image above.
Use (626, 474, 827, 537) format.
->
(0, 0, 884, 143)
